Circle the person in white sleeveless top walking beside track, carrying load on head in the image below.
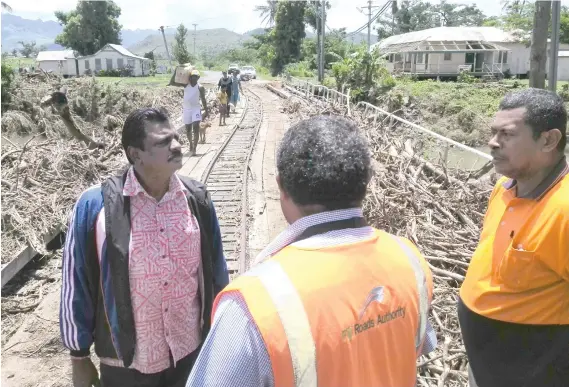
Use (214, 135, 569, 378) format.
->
(183, 70, 209, 156)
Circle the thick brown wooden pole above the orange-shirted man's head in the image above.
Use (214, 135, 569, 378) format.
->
(529, 1, 551, 89)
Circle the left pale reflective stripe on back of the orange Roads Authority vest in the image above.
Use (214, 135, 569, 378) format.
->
(243, 260, 318, 387)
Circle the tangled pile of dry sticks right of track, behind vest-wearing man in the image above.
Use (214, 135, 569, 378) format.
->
(285, 96, 496, 387)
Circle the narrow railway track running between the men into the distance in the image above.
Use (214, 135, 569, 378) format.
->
(201, 88, 263, 278)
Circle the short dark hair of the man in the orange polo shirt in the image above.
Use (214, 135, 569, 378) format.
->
(500, 88, 567, 152)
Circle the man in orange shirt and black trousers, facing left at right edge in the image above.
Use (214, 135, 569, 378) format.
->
(458, 89, 569, 387)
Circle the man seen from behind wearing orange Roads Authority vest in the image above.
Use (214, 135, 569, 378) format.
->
(186, 116, 436, 387)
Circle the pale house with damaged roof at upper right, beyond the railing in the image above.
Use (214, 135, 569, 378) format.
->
(371, 27, 569, 78)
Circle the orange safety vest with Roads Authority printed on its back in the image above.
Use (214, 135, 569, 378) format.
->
(213, 230, 433, 387)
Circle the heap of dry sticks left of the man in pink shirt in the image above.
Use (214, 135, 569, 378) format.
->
(2, 133, 126, 263)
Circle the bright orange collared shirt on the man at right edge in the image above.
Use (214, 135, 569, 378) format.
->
(460, 158, 569, 325)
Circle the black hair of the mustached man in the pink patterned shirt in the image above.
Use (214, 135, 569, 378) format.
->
(121, 107, 170, 164)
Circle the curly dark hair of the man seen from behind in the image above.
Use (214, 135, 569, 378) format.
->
(277, 116, 372, 210)
